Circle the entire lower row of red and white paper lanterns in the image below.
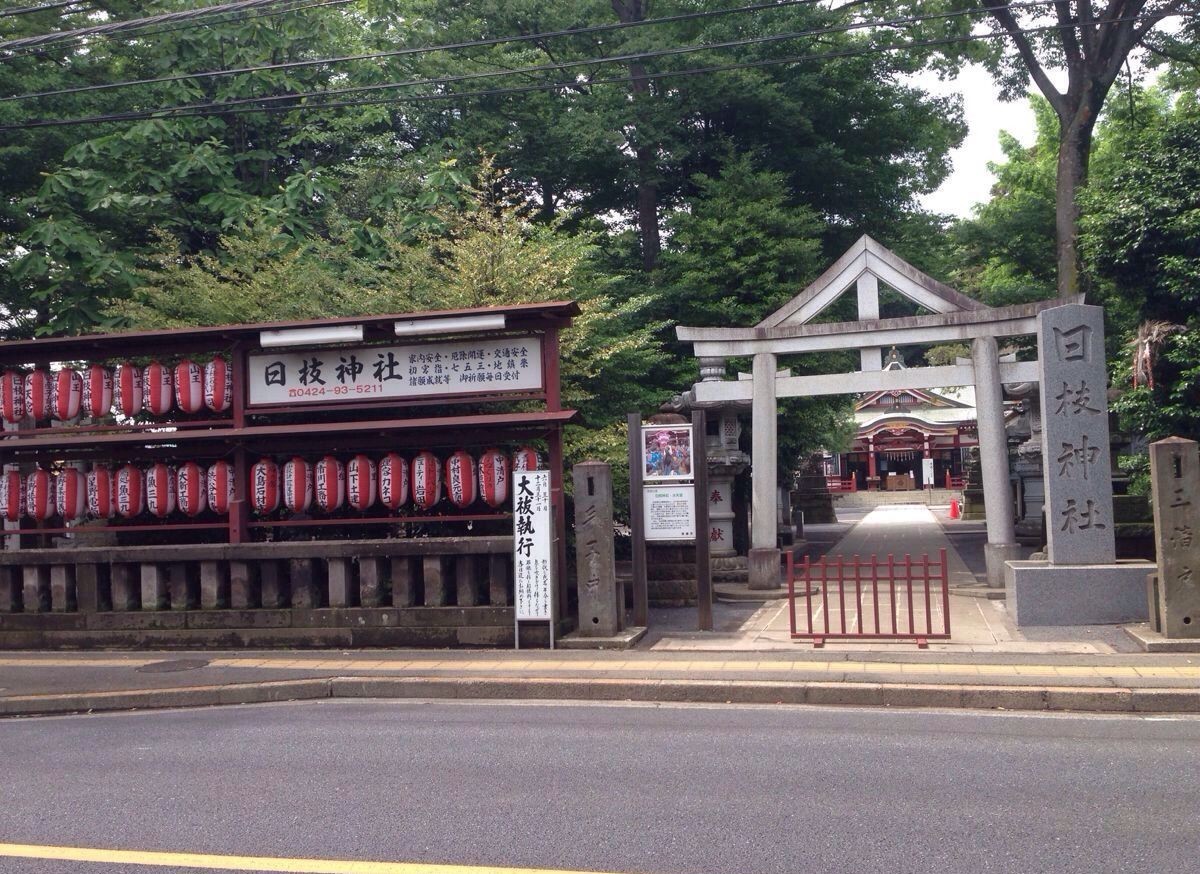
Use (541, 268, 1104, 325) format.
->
(0, 448, 538, 522)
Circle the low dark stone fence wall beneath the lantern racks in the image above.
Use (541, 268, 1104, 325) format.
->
(0, 537, 546, 648)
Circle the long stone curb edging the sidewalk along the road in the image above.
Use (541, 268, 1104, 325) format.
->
(0, 677, 1200, 717)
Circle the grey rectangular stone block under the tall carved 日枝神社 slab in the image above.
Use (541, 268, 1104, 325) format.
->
(1004, 561, 1156, 628)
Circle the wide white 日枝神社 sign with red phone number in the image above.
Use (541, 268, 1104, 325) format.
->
(246, 336, 544, 406)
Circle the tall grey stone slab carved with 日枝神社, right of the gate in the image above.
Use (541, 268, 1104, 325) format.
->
(1038, 305, 1116, 564)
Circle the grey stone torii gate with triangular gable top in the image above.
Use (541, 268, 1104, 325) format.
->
(676, 237, 1081, 588)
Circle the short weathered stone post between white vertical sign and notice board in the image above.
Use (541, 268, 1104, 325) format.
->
(571, 461, 625, 637)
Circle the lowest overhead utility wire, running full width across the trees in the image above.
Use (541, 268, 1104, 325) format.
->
(0, 11, 1189, 133)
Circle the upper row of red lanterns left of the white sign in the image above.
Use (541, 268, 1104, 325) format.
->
(0, 358, 233, 423)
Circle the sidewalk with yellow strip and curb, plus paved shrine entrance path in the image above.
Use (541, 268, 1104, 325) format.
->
(0, 507, 1200, 716)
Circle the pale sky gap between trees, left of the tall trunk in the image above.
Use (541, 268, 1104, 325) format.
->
(913, 66, 1034, 217)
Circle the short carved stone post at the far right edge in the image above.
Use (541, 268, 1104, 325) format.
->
(1150, 437, 1200, 637)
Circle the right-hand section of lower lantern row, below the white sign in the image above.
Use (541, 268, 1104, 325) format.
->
(250, 447, 538, 515)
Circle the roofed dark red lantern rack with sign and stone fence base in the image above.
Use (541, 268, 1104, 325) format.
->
(0, 301, 578, 648)
